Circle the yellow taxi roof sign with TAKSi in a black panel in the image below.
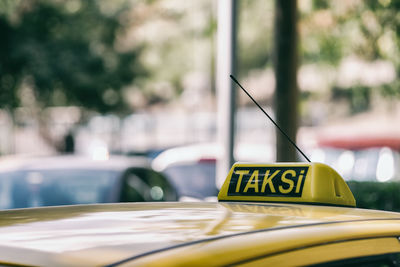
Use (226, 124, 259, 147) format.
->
(218, 163, 356, 207)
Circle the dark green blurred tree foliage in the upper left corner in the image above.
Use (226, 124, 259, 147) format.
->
(0, 0, 144, 112)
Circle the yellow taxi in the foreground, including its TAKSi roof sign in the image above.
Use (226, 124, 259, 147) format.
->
(0, 163, 400, 266)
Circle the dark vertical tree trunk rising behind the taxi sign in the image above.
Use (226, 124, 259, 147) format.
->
(274, 0, 298, 161)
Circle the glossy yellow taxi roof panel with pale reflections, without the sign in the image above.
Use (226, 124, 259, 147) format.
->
(0, 202, 400, 266)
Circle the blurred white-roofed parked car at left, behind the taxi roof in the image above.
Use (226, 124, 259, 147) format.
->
(0, 155, 178, 209)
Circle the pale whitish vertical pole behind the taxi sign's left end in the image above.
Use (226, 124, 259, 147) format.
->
(216, 0, 237, 188)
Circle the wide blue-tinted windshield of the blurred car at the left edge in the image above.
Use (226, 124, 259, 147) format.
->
(0, 169, 118, 209)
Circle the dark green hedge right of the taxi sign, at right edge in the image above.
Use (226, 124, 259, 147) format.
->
(347, 181, 400, 211)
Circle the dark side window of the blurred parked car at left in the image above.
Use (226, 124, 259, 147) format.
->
(121, 168, 177, 202)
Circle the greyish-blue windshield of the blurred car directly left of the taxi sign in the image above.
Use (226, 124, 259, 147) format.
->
(163, 161, 218, 199)
